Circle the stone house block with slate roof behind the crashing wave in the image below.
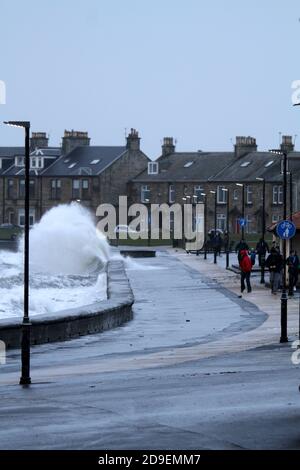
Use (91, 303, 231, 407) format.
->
(0, 129, 149, 225)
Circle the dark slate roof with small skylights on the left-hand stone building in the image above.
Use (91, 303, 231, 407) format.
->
(42, 146, 127, 176)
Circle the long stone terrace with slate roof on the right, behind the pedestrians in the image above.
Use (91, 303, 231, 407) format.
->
(129, 136, 300, 239)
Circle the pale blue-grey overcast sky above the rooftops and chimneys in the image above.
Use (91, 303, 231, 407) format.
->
(0, 0, 300, 158)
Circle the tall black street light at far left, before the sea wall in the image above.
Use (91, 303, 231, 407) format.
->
(4, 121, 31, 385)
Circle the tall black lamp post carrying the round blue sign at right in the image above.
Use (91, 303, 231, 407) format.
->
(272, 150, 288, 343)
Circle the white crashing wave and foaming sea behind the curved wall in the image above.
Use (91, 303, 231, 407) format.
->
(0, 203, 110, 318)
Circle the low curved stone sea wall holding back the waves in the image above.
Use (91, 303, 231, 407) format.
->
(0, 260, 134, 349)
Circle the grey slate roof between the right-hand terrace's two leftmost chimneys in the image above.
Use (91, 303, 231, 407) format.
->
(133, 152, 234, 182)
